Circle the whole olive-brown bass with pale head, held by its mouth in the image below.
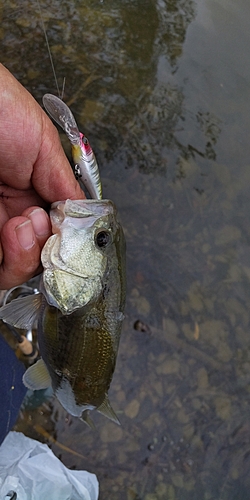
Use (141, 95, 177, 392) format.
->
(0, 199, 126, 426)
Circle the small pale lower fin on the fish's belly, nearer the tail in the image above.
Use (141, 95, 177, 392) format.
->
(23, 359, 51, 391)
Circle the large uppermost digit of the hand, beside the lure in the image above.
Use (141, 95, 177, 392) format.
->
(0, 64, 85, 203)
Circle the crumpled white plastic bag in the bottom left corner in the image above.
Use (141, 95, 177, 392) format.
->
(0, 432, 98, 500)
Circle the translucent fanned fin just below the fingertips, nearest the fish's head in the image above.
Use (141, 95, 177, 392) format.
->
(0, 293, 43, 330)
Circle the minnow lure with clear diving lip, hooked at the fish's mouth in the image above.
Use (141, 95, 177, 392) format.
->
(43, 94, 102, 200)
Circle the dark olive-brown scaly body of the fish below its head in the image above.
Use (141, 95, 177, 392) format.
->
(38, 306, 115, 406)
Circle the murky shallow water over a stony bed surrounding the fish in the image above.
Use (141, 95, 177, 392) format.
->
(0, 0, 250, 500)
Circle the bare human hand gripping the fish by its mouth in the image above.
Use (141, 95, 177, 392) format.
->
(0, 64, 85, 289)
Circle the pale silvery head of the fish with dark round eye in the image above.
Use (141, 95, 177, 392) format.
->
(41, 200, 119, 314)
